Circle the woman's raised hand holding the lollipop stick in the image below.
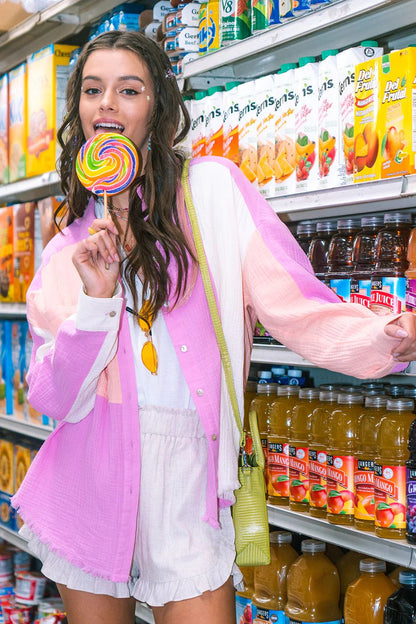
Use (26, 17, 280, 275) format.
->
(72, 218, 120, 297)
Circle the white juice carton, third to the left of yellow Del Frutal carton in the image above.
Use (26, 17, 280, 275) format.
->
(293, 56, 319, 193)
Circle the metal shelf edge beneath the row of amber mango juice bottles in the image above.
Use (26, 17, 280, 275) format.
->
(267, 505, 416, 569)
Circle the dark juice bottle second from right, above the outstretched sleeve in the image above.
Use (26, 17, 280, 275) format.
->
(350, 217, 383, 308)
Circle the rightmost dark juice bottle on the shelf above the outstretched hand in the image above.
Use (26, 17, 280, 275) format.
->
(370, 212, 412, 314)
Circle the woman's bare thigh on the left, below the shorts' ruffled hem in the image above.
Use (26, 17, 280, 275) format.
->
(57, 584, 136, 624)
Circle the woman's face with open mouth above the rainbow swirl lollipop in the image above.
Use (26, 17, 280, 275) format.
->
(79, 49, 154, 162)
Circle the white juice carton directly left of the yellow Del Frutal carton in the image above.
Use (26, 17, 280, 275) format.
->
(337, 41, 383, 184)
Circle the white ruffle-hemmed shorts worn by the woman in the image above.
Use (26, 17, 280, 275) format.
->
(20, 407, 242, 607)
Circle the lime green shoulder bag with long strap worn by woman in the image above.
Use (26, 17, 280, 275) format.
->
(182, 160, 270, 566)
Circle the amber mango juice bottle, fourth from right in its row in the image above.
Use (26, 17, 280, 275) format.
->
(309, 389, 338, 518)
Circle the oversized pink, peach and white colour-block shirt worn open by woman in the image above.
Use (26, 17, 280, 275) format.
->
(12, 158, 405, 582)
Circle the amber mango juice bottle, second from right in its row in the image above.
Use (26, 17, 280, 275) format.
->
(354, 395, 387, 531)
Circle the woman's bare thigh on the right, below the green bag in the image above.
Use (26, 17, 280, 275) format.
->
(152, 578, 235, 624)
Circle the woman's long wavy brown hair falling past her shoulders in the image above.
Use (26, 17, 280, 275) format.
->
(57, 31, 194, 314)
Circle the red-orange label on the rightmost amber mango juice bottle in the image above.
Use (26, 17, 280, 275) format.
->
(374, 463, 406, 529)
